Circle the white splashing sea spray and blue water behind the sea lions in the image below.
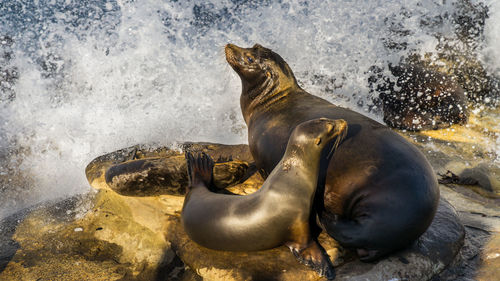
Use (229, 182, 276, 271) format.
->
(0, 0, 500, 218)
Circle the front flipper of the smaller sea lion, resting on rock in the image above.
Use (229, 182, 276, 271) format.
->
(289, 240, 335, 280)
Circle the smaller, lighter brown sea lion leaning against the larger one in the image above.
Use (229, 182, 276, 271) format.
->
(181, 118, 347, 278)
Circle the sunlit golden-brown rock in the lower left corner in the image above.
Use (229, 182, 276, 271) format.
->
(0, 190, 182, 280)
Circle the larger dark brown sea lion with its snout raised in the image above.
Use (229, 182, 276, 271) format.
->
(225, 44, 439, 261)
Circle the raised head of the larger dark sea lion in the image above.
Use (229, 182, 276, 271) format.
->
(225, 44, 297, 95)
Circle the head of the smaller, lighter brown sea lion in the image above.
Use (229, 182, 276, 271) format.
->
(287, 118, 347, 157)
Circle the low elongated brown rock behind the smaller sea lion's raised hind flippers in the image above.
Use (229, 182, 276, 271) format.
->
(85, 142, 255, 196)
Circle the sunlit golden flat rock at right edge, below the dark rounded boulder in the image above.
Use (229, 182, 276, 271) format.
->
(402, 108, 500, 196)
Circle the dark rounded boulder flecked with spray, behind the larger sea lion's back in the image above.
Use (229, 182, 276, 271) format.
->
(369, 64, 468, 131)
